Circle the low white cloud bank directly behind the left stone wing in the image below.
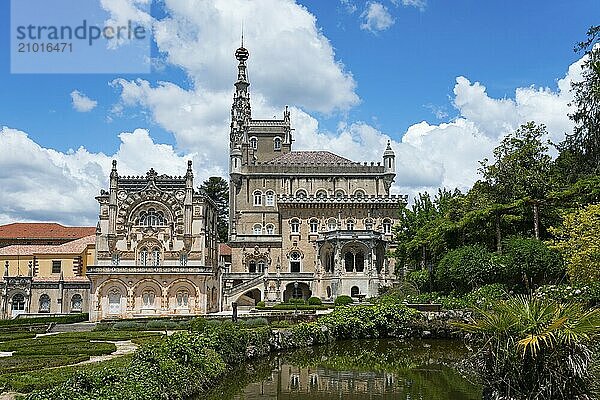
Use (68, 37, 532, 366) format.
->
(0, 127, 223, 225)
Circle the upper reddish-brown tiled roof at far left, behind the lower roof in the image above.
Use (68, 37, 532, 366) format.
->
(0, 222, 96, 239)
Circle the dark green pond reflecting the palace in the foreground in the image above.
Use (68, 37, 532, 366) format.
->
(202, 340, 481, 400)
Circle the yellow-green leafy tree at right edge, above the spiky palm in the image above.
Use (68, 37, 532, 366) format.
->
(550, 204, 600, 283)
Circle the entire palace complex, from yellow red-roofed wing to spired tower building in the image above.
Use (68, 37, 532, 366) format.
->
(0, 43, 406, 321)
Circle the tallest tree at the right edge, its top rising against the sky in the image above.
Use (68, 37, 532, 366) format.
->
(559, 25, 600, 177)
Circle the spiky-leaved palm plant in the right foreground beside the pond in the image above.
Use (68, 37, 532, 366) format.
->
(457, 296, 600, 400)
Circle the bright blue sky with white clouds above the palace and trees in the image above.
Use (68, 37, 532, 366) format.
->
(0, 0, 600, 223)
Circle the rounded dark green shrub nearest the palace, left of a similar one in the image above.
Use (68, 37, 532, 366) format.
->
(435, 245, 498, 293)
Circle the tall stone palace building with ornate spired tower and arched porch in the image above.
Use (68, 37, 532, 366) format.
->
(223, 47, 406, 308)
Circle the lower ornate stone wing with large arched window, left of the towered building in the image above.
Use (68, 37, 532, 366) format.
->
(87, 161, 220, 320)
